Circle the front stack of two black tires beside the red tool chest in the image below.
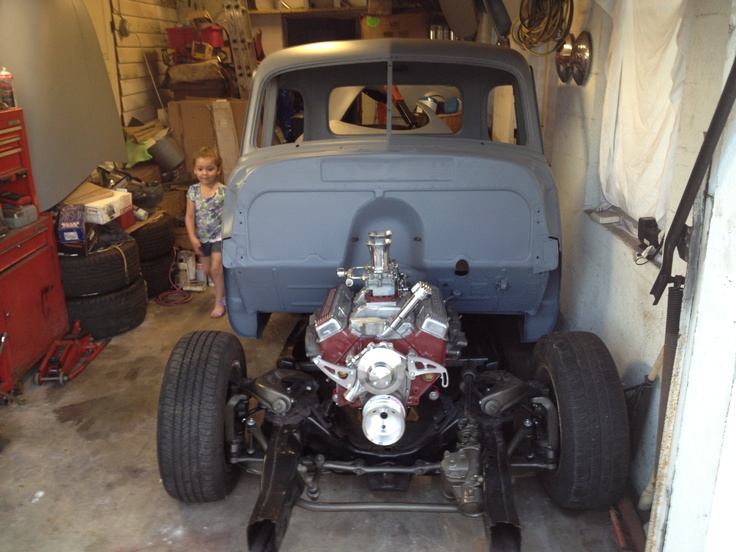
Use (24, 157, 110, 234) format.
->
(59, 239, 148, 339)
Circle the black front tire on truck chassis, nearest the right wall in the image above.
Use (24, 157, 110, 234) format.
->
(533, 332, 629, 509)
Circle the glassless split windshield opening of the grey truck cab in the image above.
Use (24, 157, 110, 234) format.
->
(256, 62, 528, 148)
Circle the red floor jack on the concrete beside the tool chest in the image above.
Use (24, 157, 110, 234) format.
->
(33, 320, 109, 385)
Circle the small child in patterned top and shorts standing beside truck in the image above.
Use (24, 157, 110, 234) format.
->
(184, 147, 225, 318)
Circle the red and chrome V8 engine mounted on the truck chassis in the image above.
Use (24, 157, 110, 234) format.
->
(306, 231, 467, 446)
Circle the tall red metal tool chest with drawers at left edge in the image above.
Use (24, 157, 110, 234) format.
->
(0, 108, 69, 393)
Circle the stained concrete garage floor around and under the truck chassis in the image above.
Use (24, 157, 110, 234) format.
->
(0, 292, 619, 552)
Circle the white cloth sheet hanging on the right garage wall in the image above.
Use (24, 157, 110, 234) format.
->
(596, 0, 686, 228)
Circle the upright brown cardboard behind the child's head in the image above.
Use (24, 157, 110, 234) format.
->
(167, 98, 248, 183)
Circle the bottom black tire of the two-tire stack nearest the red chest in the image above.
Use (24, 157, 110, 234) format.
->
(66, 278, 148, 339)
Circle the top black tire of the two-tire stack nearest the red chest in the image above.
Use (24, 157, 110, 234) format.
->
(59, 240, 141, 297)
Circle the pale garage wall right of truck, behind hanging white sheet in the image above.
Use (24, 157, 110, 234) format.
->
(551, 0, 732, 491)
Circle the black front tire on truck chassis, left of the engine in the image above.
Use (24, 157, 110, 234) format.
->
(156, 331, 246, 502)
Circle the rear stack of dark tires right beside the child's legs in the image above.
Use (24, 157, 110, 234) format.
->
(130, 211, 176, 297)
